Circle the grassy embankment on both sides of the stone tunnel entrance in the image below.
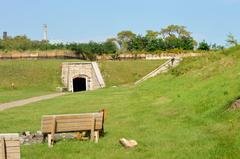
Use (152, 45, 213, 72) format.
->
(0, 60, 164, 103)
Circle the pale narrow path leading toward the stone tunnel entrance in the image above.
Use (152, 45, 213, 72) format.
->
(0, 93, 67, 111)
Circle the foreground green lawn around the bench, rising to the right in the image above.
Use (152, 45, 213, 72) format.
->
(0, 49, 240, 159)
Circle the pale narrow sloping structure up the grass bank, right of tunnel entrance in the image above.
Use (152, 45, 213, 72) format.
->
(134, 58, 182, 85)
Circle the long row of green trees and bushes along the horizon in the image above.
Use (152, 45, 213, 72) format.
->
(0, 25, 227, 55)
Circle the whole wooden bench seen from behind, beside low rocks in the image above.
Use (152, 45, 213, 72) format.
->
(41, 109, 105, 147)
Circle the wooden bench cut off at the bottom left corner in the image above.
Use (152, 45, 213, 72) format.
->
(0, 134, 20, 159)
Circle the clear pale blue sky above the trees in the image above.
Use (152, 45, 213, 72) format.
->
(0, 0, 240, 44)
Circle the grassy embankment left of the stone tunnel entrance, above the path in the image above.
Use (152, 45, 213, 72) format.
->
(0, 60, 61, 103)
